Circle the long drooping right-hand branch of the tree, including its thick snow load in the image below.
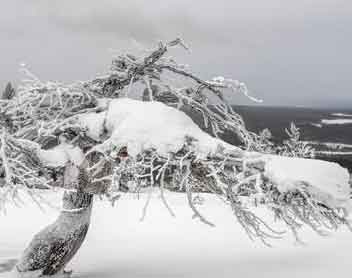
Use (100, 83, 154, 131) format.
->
(75, 99, 350, 243)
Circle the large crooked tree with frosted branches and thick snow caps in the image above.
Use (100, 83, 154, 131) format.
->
(0, 39, 350, 277)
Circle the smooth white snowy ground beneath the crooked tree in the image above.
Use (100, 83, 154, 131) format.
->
(0, 192, 352, 278)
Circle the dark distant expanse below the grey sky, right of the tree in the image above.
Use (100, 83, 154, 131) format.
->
(187, 106, 352, 171)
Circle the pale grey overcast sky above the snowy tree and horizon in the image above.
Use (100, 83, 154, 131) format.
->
(0, 0, 352, 108)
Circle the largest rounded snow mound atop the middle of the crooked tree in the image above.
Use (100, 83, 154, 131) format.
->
(79, 98, 238, 157)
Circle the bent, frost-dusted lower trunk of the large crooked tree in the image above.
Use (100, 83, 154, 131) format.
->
(16, 191, 93, 275)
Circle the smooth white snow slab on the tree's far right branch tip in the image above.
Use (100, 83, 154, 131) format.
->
(264, 155, 351, 205)
